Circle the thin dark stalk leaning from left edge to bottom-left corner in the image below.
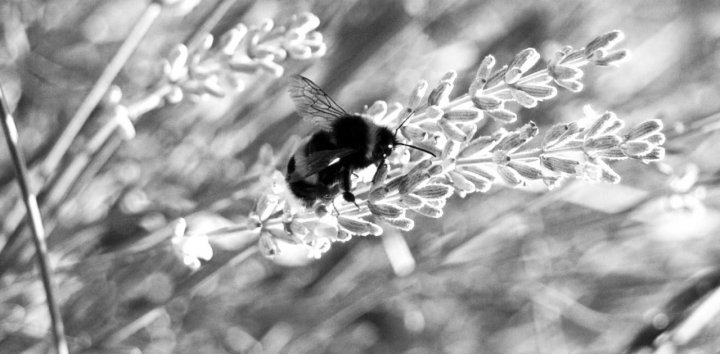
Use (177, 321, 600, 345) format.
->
(0, 87, 69, 354)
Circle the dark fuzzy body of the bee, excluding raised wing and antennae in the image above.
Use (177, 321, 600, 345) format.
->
(286, 115, 396, 206)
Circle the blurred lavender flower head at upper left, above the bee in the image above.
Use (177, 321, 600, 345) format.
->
(163, 13, 327, 103)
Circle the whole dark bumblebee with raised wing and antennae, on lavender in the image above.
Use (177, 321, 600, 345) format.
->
(286, 75, 435, 207)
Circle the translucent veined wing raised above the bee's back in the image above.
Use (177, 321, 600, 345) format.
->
(288, 75, 349, 130)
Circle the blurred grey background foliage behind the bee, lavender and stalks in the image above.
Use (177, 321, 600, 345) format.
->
(0, 0, 720, 353)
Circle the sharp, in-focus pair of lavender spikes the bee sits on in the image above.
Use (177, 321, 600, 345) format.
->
(187, 31, 665, 258)
